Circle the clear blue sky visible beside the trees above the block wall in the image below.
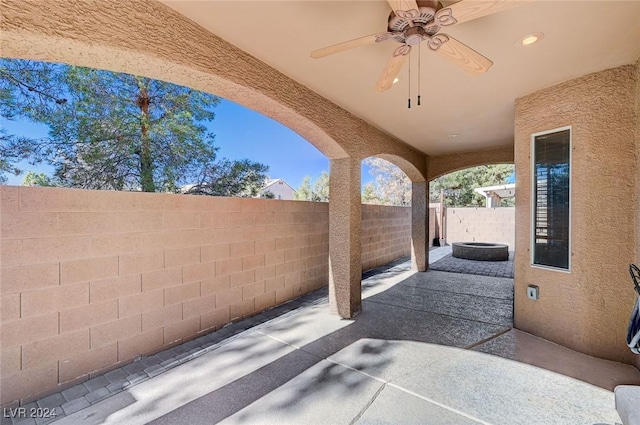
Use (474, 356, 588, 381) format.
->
(0, 100, 380, 188)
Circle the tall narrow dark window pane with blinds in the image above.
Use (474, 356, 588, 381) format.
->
(532, 128, 571, 270)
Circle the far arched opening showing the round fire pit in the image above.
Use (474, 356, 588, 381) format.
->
(429, 164, 516, 278)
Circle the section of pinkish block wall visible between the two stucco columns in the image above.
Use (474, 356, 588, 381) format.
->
(361, 204, 411, 271)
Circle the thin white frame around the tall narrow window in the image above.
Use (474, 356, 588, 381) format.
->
(529, 125, 573, 273)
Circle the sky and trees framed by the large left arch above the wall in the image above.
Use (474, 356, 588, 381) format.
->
(0, 59, 328, 200)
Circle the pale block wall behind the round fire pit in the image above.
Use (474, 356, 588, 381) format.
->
(445, 208, 515, 250)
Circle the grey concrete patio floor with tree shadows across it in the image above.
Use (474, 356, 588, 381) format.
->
(38, 256, 640, 425)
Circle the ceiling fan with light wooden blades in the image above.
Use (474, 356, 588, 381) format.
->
(311, 0, 524, 92)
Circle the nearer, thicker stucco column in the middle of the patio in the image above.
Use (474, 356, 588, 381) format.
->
(329, 158, 362, 318)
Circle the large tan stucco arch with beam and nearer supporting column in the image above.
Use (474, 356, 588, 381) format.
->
(0, 0, 426, 317)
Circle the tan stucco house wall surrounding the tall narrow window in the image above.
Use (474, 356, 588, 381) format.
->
(515, 65, 638, 363)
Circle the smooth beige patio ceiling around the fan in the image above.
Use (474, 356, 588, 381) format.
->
(163, 0, 640, 155)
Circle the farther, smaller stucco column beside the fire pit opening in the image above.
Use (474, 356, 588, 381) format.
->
(411, 182, 430, 272)
